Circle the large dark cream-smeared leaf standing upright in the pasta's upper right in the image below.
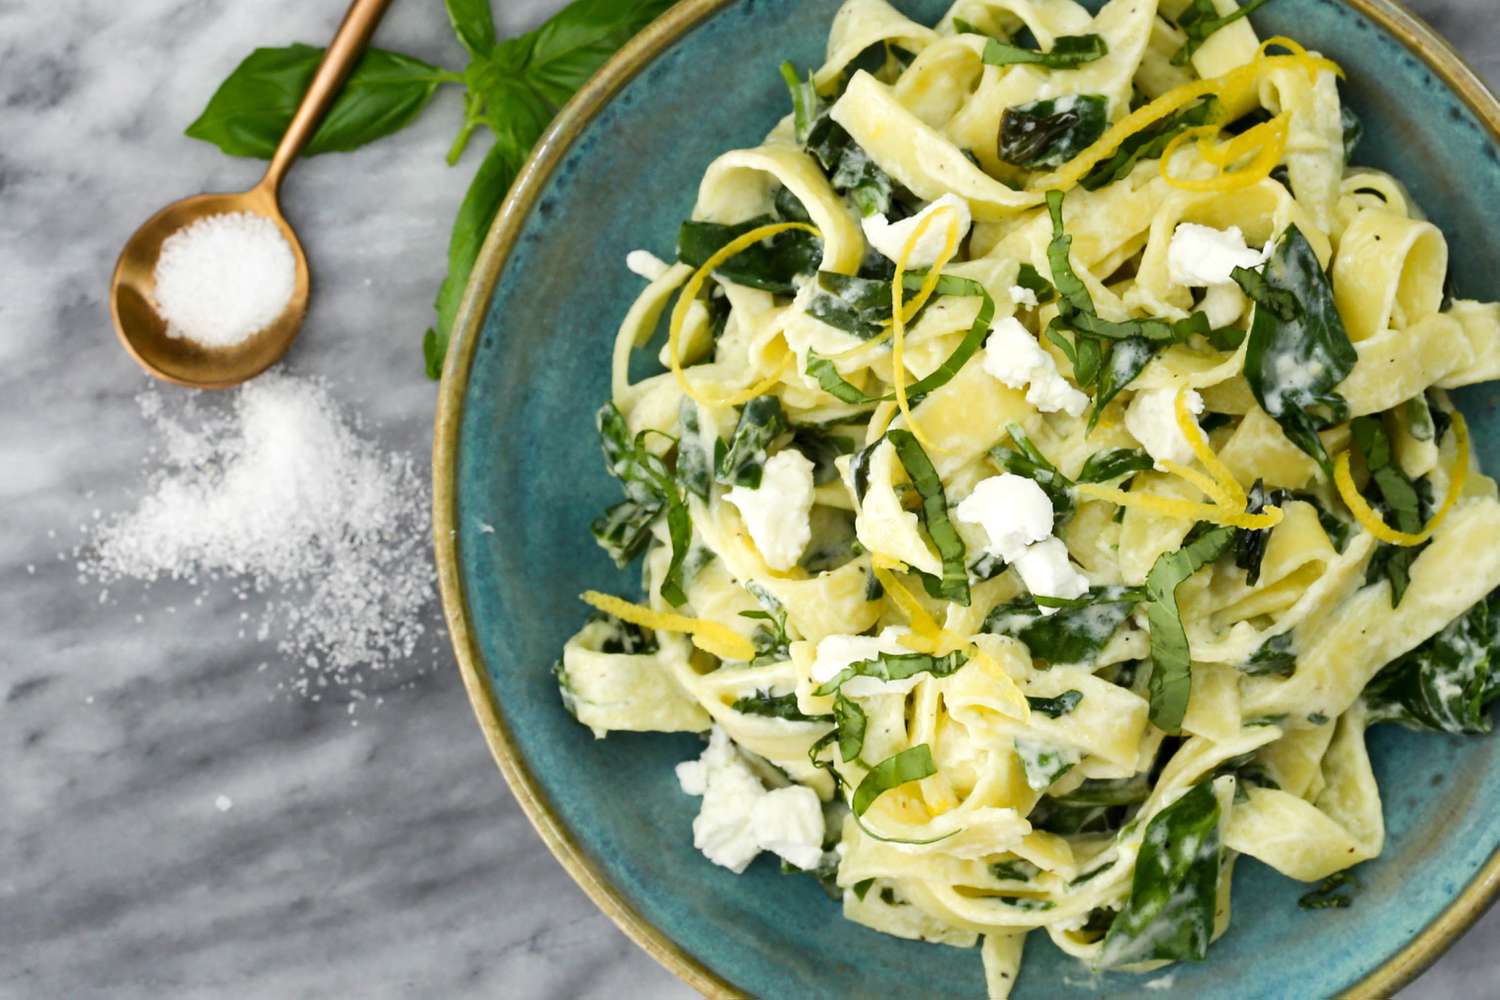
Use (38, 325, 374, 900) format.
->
(1235, 225, 1359, 478)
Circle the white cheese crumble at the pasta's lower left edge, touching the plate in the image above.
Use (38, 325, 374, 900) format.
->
(677, 726, 824, 873)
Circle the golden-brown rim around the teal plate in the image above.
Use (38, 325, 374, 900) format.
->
(432, 0, 1500, 999)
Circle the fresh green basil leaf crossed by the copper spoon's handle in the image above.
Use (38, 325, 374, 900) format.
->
(188, 43, 458, 159)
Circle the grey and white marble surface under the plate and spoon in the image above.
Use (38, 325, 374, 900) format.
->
(0, 0, 1500, 999)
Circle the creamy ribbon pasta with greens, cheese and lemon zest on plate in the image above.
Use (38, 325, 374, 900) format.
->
(555, 0, 1500, 997)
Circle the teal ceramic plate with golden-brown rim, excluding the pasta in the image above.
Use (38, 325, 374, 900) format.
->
(435, 0, 1500, 1000)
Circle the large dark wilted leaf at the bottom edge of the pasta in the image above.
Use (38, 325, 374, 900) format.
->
(1100, 781, 1223, 967)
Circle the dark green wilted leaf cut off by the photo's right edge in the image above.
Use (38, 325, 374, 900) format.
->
(1364, 591, 1500, 733)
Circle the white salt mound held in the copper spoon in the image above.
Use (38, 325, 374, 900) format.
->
(153, 211, 297, 348)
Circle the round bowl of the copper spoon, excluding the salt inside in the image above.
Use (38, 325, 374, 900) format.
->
(110, 184, 309, 388)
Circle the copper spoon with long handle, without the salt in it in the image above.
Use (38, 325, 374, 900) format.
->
(110, 0, 390, 388)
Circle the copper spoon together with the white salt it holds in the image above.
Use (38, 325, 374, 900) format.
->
(110, 0, 390, 388)
